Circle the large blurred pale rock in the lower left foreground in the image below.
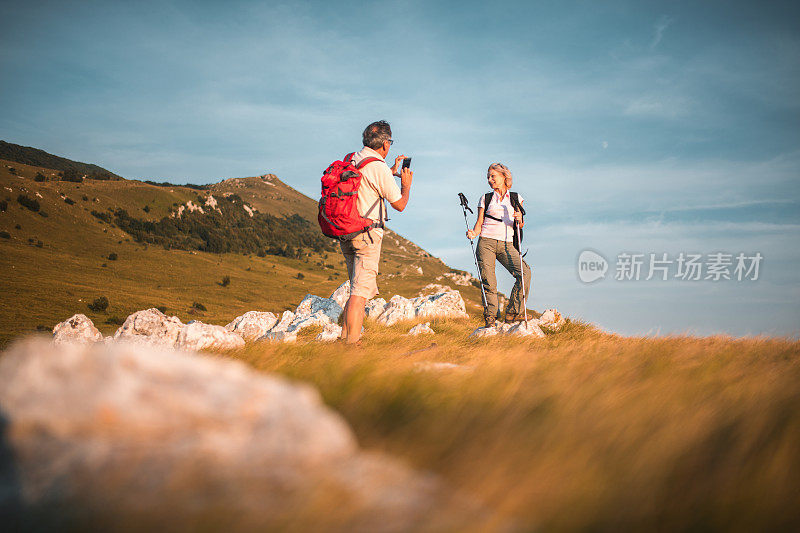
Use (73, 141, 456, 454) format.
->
(0, 338, 479, 531)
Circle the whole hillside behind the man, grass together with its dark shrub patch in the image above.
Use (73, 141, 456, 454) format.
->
(0, 155, 480, 345)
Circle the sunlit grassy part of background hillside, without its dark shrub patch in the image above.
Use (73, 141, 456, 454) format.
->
(0, 161, 480, 345)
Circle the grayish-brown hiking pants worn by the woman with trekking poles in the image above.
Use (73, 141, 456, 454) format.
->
(477, 237, 531, 317)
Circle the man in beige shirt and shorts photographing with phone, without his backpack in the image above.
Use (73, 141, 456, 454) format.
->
(339, 120, 414, 344)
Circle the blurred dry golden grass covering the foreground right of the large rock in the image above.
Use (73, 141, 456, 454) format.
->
(227, 319, 800, 531)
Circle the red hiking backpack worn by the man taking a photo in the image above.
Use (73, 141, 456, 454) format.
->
(317, 152, 383, 241)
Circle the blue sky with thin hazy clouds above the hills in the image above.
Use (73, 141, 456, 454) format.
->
(0, 1, 800, 335)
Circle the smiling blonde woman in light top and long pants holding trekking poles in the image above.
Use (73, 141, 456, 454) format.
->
(467, 163, 531, 328)
